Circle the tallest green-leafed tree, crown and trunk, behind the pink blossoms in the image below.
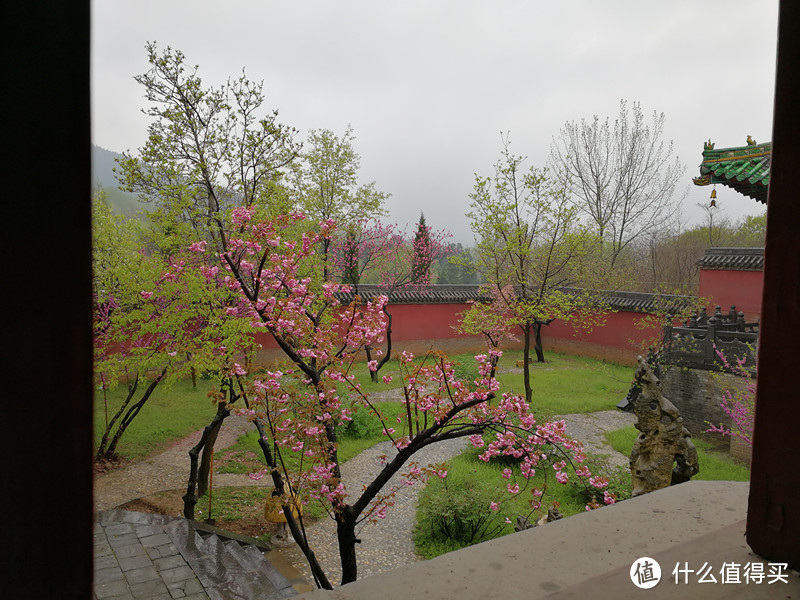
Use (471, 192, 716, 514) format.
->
(111, 43, 314, 492)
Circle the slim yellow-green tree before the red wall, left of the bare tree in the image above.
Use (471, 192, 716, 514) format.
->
(467, 138, 597, 402)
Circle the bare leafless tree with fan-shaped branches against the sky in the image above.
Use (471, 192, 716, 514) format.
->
(550, 100, 685, 268)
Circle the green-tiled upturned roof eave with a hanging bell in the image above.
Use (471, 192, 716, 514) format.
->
(694, 142, 772, 204)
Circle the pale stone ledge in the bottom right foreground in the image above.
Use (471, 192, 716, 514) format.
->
(300, 481, 800, 600)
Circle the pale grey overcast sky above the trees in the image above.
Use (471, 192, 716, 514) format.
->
(92, 0, 778, 242)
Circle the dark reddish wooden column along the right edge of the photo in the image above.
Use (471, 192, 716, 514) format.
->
(747, 0, 800, 569)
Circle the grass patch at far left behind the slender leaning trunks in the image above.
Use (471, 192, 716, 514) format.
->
(94, 379, 216, 460)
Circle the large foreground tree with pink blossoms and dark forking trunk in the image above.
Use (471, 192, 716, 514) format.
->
(158, 208, 604, 587)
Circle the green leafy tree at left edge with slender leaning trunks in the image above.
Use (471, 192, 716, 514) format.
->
(93, 196, 243, 460)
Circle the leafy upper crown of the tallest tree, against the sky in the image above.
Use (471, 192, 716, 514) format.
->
(118, 42, 299, 252)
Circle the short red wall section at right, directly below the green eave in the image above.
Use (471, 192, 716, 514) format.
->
(699, 269, 764, 321)
